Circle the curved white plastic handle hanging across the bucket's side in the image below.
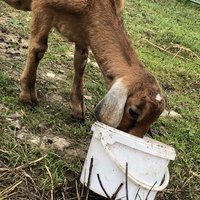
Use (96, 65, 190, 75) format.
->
(100, 133, 169, 192)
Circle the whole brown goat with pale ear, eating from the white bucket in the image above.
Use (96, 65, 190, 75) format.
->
(3, 0, 165, 137)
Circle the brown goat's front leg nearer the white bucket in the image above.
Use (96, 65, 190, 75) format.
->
(71, 44, 88, 121)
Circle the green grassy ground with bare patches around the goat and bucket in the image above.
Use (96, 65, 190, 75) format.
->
(0, 0, 200, 200)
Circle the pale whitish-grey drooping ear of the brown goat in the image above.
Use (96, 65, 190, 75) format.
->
(95, 80, 128, 128)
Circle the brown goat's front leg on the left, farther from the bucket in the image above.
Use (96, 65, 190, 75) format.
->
(19, 13, 51, 105)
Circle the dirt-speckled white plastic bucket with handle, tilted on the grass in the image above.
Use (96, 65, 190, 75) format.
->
(80, 122, 176, 200)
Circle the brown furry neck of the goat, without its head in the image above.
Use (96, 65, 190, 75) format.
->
(86, 1, 141, 85)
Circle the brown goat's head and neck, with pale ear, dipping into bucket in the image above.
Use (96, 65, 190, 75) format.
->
(91, 0, 165, 137)
